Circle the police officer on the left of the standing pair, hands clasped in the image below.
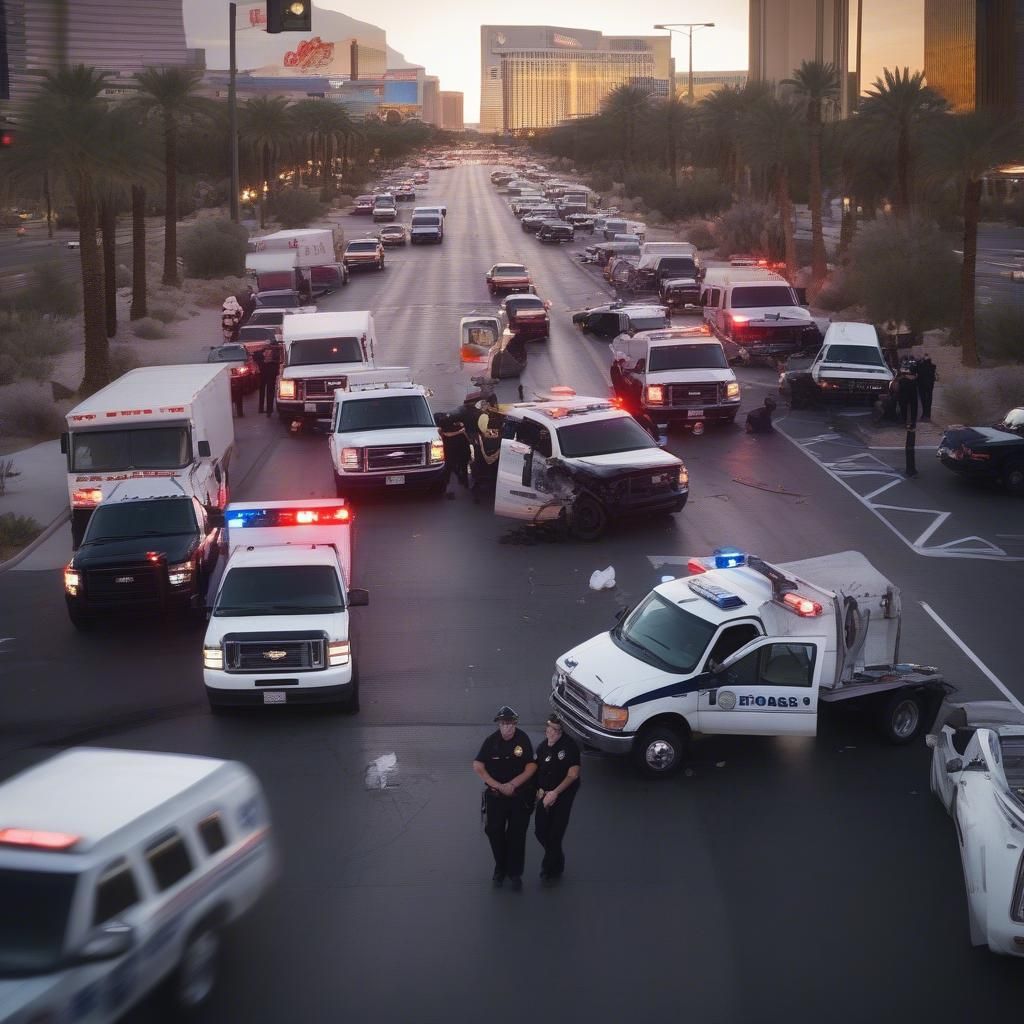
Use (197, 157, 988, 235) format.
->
(473, 705, 537, 889)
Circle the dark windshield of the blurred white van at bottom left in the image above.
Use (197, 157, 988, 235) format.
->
(0, 868, 78, 976)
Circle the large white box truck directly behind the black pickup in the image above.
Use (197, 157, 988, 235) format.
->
(60, 364, 234, 548)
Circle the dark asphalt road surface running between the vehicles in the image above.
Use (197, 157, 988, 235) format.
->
(0, 166, 1024, 1024)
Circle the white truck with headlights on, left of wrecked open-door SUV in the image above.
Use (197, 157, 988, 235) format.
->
(329, 367, 444, 497)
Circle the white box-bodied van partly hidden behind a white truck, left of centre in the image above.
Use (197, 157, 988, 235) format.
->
(278, 312, 376, 427)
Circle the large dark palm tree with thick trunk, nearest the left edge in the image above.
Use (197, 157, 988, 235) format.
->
(9, 65, 124, 394)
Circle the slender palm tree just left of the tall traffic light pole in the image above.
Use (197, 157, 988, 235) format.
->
(133, 68, 210, 286)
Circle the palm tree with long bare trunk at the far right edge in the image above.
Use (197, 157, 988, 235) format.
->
(932, 111, 1024, 367)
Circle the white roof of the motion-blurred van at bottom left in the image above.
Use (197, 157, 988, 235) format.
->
(0, 746, 229, 854)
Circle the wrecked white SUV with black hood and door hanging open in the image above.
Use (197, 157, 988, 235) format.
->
(495, 388, 689, 541)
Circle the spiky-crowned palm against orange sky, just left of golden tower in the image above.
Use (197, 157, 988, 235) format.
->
(857, 68, 948, 217)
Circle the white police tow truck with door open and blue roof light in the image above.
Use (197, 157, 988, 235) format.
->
(552, 549, 949, 776)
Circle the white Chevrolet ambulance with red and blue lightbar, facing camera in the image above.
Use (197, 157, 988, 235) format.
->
(203, 498, 370, 714)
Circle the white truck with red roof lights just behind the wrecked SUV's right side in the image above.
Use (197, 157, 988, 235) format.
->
(609, 325, 739, 423)
